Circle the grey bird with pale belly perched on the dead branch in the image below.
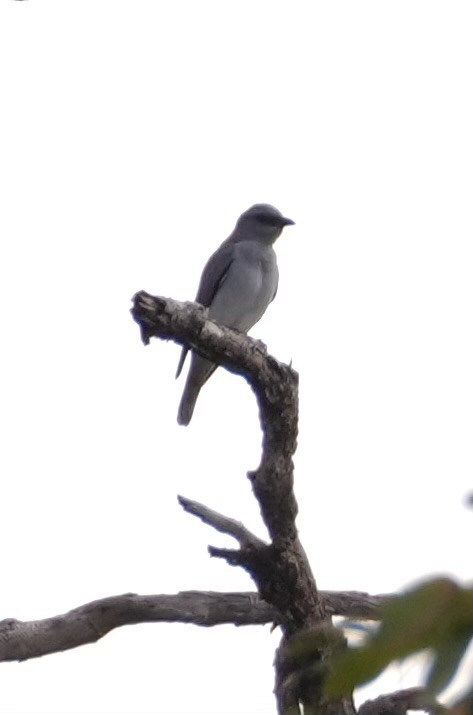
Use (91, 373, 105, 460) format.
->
(176, 204, 294, 425)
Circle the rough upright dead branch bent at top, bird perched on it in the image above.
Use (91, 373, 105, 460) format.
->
(132, 292, 354, 715)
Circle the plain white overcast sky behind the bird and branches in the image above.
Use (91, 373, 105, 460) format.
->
(0, 0, 473, 715)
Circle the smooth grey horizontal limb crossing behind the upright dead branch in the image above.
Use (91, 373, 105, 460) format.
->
(0, 591, 386, 662)
